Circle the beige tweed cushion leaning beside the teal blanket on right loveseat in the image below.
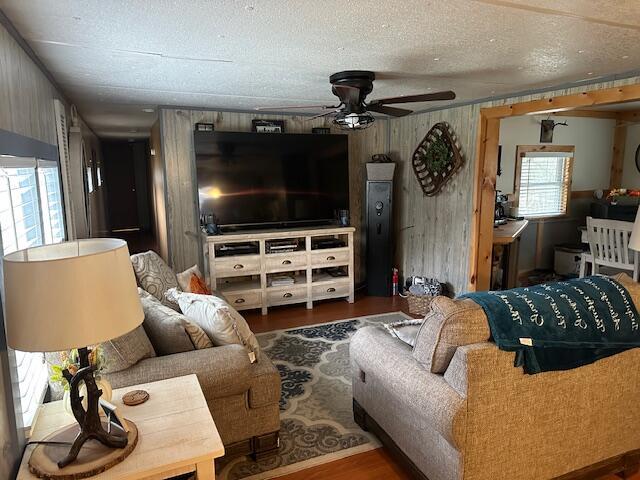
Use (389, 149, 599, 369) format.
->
(413, 297, 491, 373)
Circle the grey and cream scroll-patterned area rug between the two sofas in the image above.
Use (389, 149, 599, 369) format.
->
(216, 312, 410, 480)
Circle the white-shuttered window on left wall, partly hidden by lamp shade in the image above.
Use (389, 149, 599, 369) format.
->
(0, 157, 65, 425)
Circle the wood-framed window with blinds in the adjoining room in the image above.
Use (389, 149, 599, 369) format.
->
(514, 145, 574, 218)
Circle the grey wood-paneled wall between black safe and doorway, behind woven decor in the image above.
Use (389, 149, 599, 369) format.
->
(389, 77, 640, 294)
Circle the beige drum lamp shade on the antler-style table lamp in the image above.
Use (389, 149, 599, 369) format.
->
(4, 238, 144, 352)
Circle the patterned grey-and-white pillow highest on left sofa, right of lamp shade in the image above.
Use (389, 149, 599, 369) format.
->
(131, 250, 179, 311)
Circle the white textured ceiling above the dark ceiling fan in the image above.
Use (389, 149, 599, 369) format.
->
(0, 0, 640, 136)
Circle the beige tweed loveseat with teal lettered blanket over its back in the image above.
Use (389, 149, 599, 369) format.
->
(350, 292, 640, 480)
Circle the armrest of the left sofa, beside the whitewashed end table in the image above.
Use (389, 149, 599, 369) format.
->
(105, 345, 255, 400)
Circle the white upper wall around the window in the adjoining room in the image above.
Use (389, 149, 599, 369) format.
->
(496, 115, 616, 193)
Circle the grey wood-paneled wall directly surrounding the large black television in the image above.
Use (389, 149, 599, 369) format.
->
(160, 108, 388, 282)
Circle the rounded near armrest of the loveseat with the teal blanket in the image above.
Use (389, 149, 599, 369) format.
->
(350, 327, 466, 447)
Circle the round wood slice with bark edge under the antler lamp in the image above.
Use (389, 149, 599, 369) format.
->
(29, 420, 138, 480)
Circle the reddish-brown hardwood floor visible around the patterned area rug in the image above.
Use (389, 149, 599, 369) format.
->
(243, 294, 640, 480)
